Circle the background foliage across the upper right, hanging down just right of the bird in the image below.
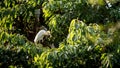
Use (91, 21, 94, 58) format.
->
(42, 0, 120, 46)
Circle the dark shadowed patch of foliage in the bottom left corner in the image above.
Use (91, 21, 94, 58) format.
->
(0, 48, 33, 68)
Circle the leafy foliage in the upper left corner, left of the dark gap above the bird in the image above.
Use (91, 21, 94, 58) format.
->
(0, 0, 41, 39)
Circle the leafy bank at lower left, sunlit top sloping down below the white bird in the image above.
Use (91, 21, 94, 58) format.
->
(0, 32, 46, 68)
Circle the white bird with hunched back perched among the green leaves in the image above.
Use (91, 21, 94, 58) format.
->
(34, 30, 51, 43)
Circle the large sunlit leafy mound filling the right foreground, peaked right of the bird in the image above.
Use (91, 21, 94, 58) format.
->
(34, 19, 120, 68)
